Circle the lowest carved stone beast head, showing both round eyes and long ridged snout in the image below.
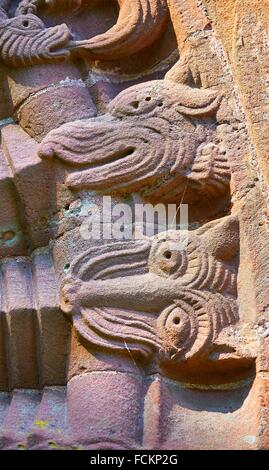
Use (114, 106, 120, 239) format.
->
(61, 216, 254, 380)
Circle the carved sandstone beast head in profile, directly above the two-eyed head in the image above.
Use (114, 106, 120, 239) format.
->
(39, 80, 230, 203)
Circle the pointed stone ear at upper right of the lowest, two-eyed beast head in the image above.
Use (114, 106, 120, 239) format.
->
(198, 216, 240, 261)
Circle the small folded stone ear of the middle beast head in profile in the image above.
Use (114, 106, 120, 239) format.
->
(176, 84, 222, 117)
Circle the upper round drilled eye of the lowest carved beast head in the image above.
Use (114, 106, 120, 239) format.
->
(149, 242, 188, 278)
